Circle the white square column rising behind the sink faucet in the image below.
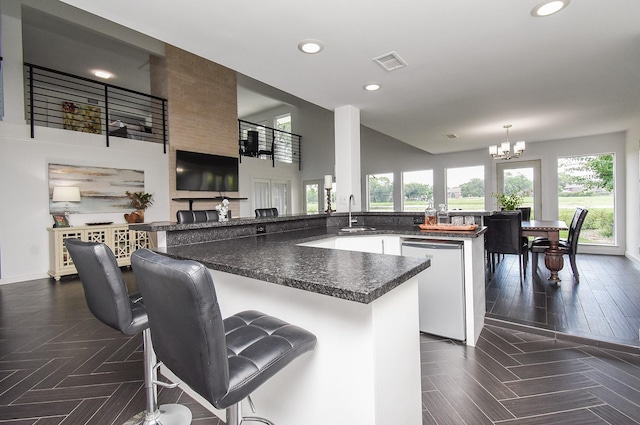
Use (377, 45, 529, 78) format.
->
(334, 105, 362, 212)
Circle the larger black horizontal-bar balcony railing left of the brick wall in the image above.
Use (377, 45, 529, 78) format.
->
(25, 64, 168, 153)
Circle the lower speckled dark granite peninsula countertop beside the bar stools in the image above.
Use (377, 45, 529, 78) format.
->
(158, 228, 430, 304)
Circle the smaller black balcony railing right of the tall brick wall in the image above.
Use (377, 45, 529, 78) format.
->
(238, 120, 302, 169)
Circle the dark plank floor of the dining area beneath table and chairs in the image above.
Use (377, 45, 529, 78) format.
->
(486, 254, 640, 347)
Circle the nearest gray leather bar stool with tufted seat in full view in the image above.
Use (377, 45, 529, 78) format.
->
(131, 249, 316, 425)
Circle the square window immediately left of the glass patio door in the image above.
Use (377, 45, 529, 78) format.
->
(447, 165, 485, 210)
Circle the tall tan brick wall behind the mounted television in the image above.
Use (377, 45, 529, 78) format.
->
(151, 45, 239, 220)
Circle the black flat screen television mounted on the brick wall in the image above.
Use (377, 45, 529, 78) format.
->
(176, 147, 238, 192)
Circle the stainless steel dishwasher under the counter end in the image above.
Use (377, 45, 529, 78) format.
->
(402, 239, 466, 341)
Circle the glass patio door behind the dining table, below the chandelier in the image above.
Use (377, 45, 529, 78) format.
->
(496, 160, 542, 220)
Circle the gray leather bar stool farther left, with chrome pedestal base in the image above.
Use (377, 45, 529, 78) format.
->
(65, 239, 191, 425)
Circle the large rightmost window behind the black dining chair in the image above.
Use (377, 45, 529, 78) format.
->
(558, 154, 615, 245)
